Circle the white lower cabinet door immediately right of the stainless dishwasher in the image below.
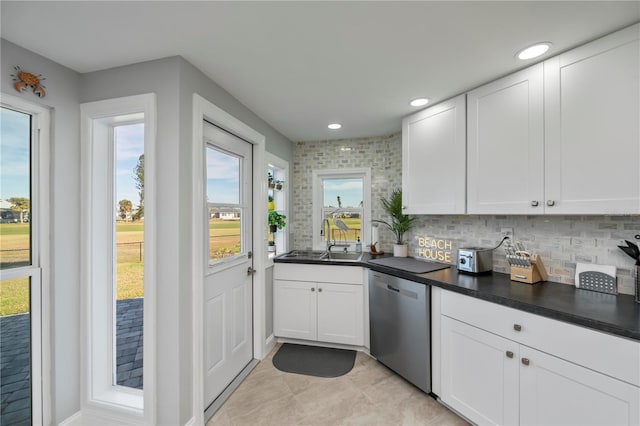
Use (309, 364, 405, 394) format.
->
(440, 315, 519, 425)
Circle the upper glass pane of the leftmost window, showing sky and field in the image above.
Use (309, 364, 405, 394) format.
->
(0, 108, 31, 269)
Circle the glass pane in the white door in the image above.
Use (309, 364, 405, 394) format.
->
(207, 146, 243, 262)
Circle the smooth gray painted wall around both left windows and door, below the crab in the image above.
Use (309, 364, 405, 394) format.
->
(2, 40, 292, 424)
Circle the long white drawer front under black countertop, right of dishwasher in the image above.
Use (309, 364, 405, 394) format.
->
(441, 291, 640, 386)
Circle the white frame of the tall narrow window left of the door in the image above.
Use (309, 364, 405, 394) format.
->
(80, 93, 156, 424)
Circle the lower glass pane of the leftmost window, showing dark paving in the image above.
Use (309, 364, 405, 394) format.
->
(0, 277, 31, 425)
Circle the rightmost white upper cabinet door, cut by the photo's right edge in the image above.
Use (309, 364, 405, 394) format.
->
(544, 25, 640, 214)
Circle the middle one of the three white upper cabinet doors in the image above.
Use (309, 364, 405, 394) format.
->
(467, 64, 544, 214)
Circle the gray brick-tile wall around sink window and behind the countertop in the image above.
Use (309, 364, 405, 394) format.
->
(291, 134, 640, 294)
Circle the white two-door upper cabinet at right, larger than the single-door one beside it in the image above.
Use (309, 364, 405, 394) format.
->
(467, 25, 640, 214)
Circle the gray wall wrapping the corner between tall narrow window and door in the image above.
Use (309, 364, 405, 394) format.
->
(81, 57, 292, 424)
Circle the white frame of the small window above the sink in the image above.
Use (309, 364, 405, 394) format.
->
(312, 167, 371, 251)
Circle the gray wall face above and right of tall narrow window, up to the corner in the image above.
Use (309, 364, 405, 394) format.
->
(81, 57, 186, 424)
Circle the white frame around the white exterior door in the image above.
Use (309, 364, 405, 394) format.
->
(191, 93, 267, 424)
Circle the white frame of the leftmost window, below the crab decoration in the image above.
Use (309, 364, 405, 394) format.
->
(0, 93, 53, 424)
